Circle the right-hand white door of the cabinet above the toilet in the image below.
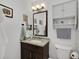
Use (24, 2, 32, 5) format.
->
(64, 0, 76, 17)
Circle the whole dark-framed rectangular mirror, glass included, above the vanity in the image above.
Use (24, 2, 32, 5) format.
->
(33, 11, 48, 36)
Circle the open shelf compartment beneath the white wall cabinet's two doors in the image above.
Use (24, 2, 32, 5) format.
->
(53, 16, 76, 26)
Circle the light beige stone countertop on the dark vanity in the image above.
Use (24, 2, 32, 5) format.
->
(21, 37, 49, 47)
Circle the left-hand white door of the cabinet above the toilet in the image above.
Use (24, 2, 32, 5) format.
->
(53, 4, 63, 18)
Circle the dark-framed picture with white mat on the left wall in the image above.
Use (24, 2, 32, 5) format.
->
(0, 4, 13, 18)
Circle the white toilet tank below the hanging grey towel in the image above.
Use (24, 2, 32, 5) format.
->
(55, 44, 72, 59)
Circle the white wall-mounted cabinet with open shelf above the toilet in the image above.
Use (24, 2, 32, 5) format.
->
(53, 0, 78, 29)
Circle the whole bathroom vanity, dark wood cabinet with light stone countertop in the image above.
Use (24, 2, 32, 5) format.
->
(21, 38, 49, 59)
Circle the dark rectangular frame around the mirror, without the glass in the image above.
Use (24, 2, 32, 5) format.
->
(33, 10, 48, 37)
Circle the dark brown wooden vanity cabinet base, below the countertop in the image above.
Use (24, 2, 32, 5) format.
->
(21, 42, 49, 59)
